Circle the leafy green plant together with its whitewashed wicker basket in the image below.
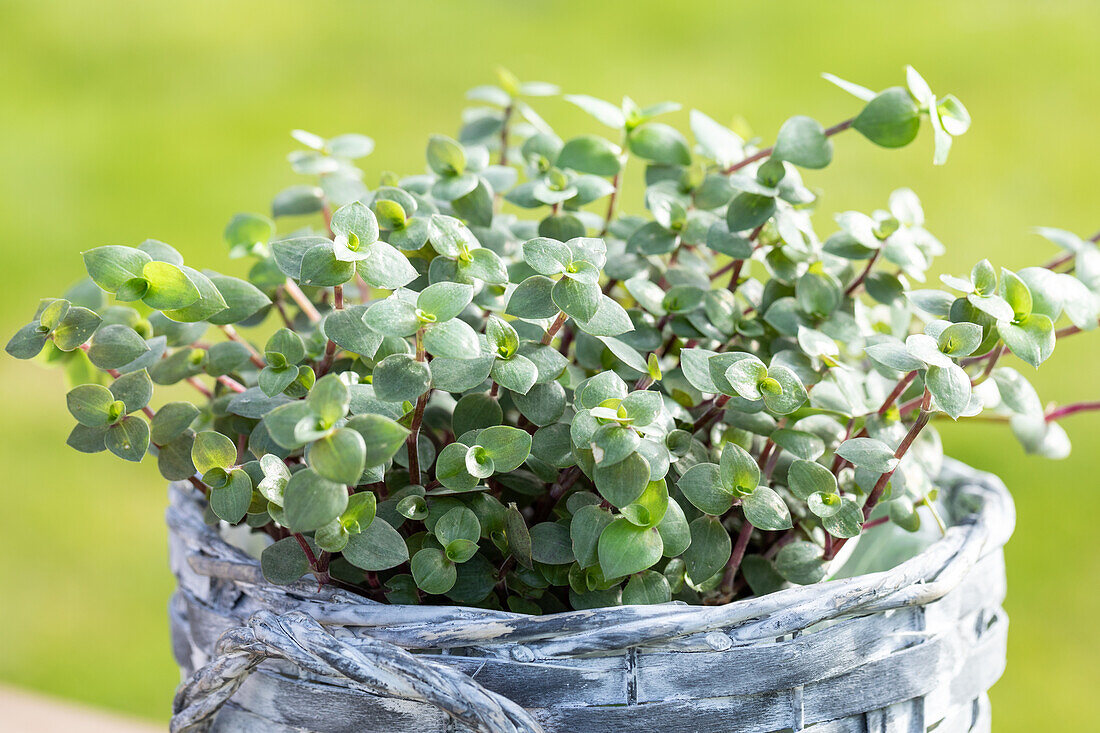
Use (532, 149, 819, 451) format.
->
(7, 68, 1100, 731)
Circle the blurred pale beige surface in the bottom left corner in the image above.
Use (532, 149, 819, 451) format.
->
(0, 686, 164, 733)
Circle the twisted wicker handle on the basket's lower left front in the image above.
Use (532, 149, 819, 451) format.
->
(169, 611, 542, 733)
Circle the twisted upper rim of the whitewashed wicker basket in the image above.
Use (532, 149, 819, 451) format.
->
(166, 458, 1015, 656)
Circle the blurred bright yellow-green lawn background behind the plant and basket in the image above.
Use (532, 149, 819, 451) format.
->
(0, 0, 1100, 731)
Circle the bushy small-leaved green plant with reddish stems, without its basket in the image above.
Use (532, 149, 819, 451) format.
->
(7, 68, 1100, 613)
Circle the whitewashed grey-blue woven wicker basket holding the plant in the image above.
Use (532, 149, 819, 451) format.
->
(168, 461, 1014, 733)
